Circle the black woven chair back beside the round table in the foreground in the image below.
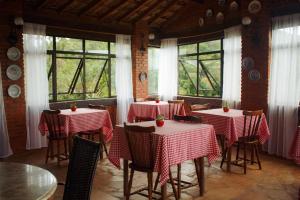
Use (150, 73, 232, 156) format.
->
(63, 136, 101, 200)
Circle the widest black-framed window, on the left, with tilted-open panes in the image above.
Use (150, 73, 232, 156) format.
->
(47, 36, 116, 101)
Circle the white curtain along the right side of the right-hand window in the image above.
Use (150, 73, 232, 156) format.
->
(222, 26, 242, 108)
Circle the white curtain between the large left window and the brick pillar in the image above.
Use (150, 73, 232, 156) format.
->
(116, 35, 133, 124)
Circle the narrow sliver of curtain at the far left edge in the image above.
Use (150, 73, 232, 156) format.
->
(0, 63, 12, 158)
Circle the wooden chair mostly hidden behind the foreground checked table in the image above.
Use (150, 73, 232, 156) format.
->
(169, 115, 202, 199)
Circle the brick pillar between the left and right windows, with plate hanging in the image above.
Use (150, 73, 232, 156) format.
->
(131, 22, 149, 98)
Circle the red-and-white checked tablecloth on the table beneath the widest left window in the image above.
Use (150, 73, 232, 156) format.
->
(39, 108, 113, 142)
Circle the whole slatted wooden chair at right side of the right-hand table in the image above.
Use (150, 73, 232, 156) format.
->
(221, 110, 263, 174)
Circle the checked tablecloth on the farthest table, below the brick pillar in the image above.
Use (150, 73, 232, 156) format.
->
(127, 101, 185, 123)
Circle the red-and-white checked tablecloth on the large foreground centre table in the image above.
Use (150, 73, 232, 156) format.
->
(108, 120, 220, 185)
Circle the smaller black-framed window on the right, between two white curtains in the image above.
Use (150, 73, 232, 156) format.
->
(178, 39, 223, 97)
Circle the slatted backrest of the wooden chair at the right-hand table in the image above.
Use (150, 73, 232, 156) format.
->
(243, 110, 263, 142)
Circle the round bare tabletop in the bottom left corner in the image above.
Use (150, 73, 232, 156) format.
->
(0, 162, 57, 200)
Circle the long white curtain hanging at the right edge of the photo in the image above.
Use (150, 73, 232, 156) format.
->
(268, 14, 300, 158)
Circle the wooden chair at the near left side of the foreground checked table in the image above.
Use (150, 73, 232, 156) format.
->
(124, 123, 177, 200)
